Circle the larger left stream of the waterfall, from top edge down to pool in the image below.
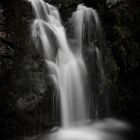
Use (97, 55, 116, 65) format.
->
(31, 0, 88, 127)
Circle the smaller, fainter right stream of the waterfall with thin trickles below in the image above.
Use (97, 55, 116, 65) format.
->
(70, 4, 104, 118)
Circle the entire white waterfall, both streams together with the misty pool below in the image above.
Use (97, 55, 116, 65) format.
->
(30, 0, 131, 140)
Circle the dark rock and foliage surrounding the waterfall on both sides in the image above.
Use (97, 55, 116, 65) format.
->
(0, 0, 140, 140)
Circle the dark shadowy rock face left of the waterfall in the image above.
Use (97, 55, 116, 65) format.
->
(0, 0, 59, 139)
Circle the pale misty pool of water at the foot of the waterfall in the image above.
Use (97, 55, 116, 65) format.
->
(40, 119, 131, 140)
